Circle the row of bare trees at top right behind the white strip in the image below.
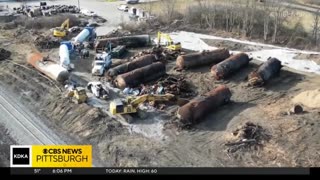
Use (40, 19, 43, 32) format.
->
(154, 0, 320, 48)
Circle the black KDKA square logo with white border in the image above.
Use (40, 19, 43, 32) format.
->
(10, 146, 31, 167)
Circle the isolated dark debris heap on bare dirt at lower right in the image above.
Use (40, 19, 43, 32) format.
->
(225, 122, 271, 153)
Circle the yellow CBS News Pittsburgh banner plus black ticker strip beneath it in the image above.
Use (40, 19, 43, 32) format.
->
(10, 145, 315, 175)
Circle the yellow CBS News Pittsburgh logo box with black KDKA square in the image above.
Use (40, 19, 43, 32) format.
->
(10, 145, 92, 168)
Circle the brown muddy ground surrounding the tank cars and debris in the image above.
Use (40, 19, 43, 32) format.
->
(0, 21, 320, 167)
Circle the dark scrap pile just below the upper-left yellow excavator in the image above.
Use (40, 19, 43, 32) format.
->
(34, 35, 60, 49)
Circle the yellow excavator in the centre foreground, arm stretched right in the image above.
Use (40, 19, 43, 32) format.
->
(109, 94, 175, 115)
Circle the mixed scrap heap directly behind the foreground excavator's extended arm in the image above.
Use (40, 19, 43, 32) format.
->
(123, 75, 196, 98)
